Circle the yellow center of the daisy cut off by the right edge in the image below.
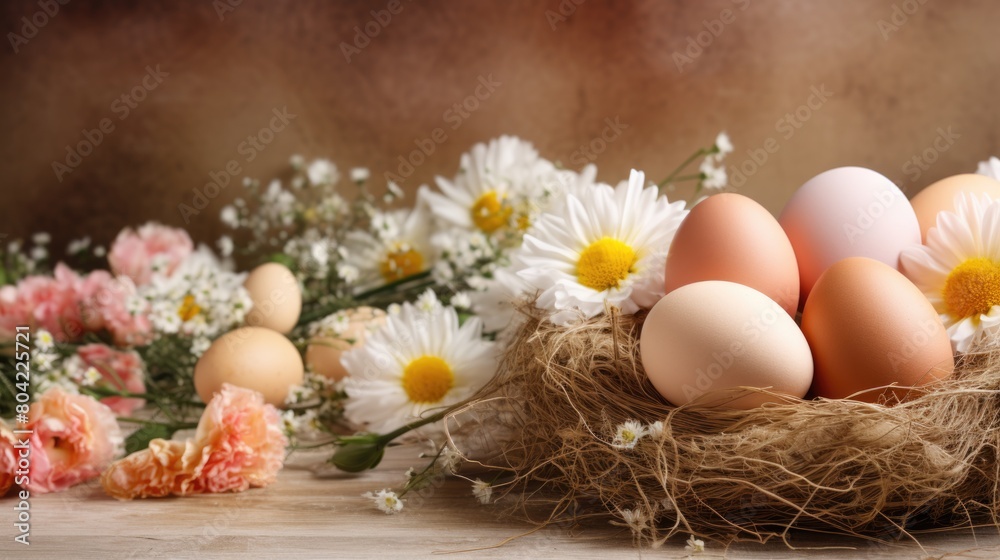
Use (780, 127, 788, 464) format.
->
(941, 257, 1000, 317)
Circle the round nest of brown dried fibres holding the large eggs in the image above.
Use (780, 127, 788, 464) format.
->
(456, 309, 1000, 545)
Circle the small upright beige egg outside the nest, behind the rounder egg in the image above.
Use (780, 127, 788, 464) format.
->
(243, 263, 302, 333)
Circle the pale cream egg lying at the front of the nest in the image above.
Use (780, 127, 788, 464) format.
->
(639, 280, 813, 409)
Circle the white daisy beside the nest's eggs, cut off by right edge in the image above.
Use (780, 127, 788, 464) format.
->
(900, 194, 1000, 352)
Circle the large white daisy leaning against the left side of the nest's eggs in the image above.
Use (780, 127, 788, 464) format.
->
(513, 170, 687, 324)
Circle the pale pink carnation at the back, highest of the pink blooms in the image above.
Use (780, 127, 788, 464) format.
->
(108, 222, 194, 286)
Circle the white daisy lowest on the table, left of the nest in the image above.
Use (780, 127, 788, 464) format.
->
(341, 303, 496, 433)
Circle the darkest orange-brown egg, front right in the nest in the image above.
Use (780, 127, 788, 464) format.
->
(802, 257, 955, 404)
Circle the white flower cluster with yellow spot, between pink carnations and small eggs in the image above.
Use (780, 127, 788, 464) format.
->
(139, 247, 253, 356)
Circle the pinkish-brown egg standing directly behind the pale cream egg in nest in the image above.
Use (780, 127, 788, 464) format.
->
(665, 193, 799, 317)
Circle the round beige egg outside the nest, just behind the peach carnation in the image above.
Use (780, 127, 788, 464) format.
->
(194, 327, 305, 406)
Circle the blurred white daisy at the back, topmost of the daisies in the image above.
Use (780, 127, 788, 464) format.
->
(427, 136, 556, 234)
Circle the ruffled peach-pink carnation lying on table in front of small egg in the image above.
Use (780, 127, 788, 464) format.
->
(101, 384, 288, 500)
